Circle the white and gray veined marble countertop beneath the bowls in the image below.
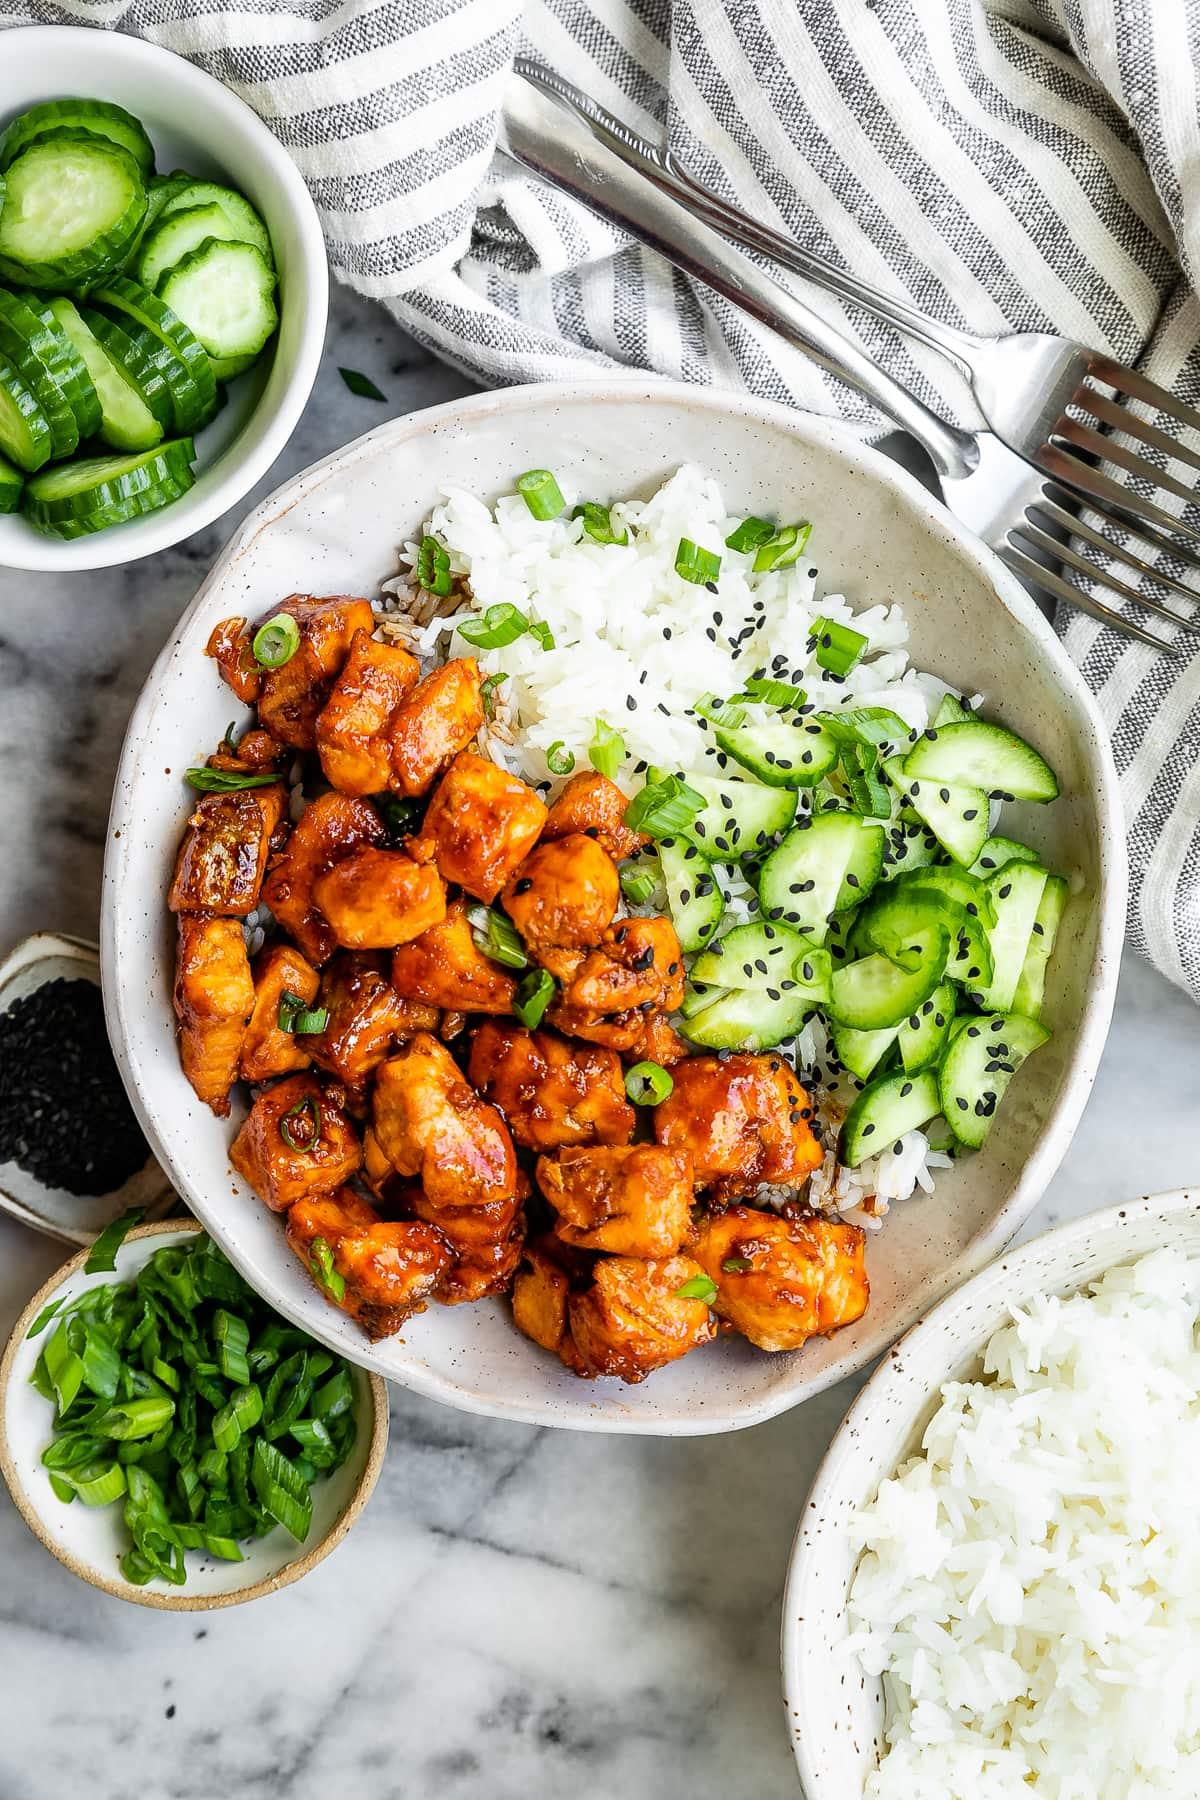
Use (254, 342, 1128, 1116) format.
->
(0, 293, 1200, 1800)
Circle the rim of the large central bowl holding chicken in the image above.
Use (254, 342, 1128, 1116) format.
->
(101, 376, 1126, 1436)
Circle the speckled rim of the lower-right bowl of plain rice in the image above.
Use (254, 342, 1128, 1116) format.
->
(779, 1188, 1200, 1800)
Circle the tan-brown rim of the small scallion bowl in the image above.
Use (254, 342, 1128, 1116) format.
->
(0, 1219, 389, 1613)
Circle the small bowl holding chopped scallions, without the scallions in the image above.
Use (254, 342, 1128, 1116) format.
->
(0, 1219, 387, 1613)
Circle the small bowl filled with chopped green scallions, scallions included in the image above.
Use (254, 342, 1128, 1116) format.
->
(0, 1219, 387, 1611)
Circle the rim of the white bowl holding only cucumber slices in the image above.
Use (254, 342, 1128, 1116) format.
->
(0, 23, 329, 574)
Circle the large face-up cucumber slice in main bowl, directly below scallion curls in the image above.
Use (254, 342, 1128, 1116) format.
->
(759, 812, 883, 943)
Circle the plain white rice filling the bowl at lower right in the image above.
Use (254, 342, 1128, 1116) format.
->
(846, 1249, 1200, 1800)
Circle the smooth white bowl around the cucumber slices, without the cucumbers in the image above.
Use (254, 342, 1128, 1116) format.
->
(0, 25, 329, 571)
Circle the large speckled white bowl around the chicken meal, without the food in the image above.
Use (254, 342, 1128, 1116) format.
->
(101, 382, 1124, 1435)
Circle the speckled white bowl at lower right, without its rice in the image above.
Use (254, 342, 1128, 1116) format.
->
(781, 1188, 1200, 1800)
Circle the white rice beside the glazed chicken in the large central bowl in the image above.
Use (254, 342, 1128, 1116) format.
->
(394, 464, 948, 1224)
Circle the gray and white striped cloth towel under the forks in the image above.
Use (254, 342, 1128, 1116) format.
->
(0, 0, 1200, 999)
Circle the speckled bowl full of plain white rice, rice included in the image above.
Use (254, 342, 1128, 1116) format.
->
(783, 1190, 1200, 1800)
